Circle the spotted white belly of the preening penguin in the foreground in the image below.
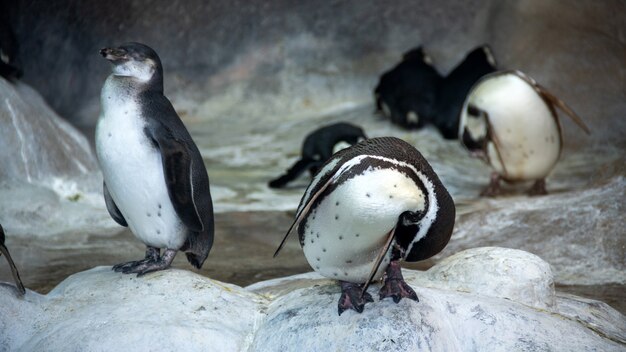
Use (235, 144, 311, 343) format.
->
(303, 169, 425, 283)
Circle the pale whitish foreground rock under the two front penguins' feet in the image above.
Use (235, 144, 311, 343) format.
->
(0, 248, 626, 351)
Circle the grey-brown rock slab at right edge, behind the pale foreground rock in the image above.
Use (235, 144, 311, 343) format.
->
(440, 176, 626, 285)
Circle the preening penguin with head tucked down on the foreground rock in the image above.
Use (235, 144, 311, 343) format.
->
(274, 137, 455, 315)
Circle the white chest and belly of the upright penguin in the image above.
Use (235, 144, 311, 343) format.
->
(96, 91, 186, 249)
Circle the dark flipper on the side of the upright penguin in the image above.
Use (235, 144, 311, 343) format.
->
(151, 129, 205, 232)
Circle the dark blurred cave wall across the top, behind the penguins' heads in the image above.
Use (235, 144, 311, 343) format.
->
(5, 0, 626, 143)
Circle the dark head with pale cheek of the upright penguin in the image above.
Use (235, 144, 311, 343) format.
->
(100, 43, 163, 82)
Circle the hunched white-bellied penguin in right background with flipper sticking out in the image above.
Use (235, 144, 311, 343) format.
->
(458, 70, 590, 196)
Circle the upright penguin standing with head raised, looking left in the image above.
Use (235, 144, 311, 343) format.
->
(95, 43, 214, 276)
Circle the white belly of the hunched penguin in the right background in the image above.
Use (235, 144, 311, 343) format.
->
(470, 75, 561, 181)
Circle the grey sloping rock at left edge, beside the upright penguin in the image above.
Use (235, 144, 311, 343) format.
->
(0, 77, 98, 186)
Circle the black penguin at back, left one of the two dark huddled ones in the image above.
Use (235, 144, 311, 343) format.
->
(374, 47, 443, 129)
